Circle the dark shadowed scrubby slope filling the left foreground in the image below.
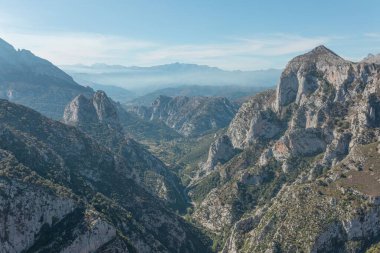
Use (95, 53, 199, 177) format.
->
(0, 100, 208, 252)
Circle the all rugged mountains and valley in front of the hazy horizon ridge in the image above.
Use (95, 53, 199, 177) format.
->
(0, 37, 380, 253)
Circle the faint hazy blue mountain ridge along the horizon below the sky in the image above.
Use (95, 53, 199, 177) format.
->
(61, 63, 281, 92)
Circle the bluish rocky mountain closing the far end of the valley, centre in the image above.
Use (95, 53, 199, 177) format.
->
(129, 96, 237, 137)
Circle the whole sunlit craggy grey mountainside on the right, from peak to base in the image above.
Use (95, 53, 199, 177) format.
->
(194, 46, 380, 252)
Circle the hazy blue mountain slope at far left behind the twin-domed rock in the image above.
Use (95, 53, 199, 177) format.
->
(0, 39, 93, 119)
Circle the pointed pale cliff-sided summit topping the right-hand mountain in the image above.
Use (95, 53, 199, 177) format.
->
(274, 46, 355, 112)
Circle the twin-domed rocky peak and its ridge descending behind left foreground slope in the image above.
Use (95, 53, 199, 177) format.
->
(63, 91, 186, 211)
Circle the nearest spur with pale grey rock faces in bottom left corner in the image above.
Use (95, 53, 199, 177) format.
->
(0, 149, 120, 253)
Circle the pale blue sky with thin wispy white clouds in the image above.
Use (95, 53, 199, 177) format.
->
(0, 0, 380, 70)
